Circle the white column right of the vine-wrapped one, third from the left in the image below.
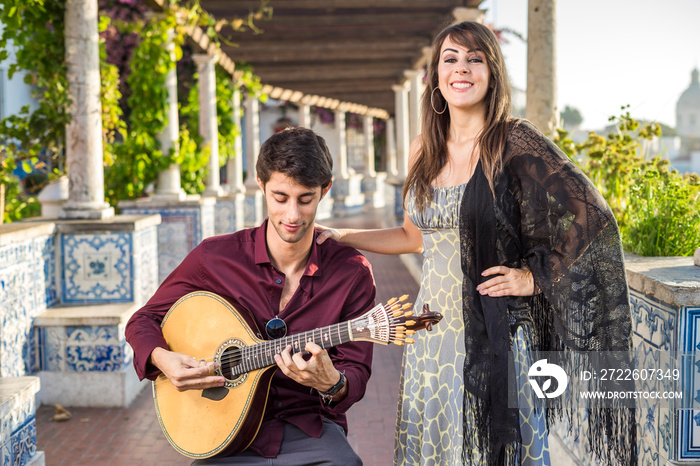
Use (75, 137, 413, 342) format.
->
(192, 53, 223, 196)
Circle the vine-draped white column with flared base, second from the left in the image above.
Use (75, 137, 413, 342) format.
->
(152, 26, 187, 201)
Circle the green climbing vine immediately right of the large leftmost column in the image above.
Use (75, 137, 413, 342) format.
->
(105, 1, 271, 205)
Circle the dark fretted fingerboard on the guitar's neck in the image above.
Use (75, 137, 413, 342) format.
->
(231, 322, 352, 377)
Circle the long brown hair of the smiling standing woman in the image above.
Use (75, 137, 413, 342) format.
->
(403, 21, 511, 211)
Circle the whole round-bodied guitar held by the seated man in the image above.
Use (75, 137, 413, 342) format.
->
(153, 291, 442, 459)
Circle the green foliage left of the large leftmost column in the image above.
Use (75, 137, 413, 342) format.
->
(0, 0, 70, 221)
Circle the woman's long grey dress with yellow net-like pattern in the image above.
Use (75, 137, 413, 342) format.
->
(394, 183, 549, 466)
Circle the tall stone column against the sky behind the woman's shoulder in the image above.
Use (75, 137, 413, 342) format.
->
(525, 0, 559, 135)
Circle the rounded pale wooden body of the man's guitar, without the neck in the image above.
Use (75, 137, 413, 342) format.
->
(153, 291, 276, 459)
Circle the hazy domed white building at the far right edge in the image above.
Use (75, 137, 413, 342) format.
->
(669, 68, 700, 173)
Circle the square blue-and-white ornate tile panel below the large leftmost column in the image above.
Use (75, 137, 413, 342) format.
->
(61, 233, 134, 303)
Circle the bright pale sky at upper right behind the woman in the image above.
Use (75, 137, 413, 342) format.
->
(480, 0, 700, 130)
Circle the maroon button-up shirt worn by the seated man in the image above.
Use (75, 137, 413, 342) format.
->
(126, 221, 376, 457)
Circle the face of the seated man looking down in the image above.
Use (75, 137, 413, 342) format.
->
(258, 172, 330, 243)
